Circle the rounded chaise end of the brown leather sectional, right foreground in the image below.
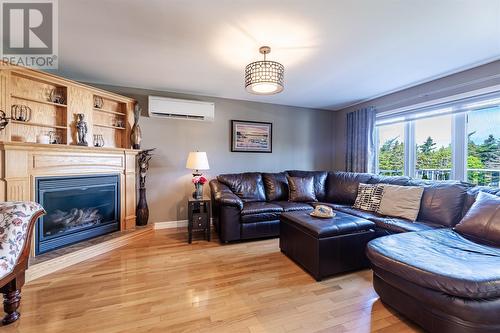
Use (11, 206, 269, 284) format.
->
(367, 187, 500, 333)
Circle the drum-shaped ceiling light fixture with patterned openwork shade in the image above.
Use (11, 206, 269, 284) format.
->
(245, 46, 285, 95)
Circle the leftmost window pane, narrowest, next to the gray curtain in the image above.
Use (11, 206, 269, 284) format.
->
(378, 123, 405, 176)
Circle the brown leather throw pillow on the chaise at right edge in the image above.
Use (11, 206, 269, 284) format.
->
(455, 192, 500, 244)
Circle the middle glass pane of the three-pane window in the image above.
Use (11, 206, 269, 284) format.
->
(415, 115, 452, 180)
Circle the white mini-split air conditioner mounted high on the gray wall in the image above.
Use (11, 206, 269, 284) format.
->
(148, 96, 215, 121)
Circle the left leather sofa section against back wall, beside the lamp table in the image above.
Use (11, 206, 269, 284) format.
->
(210, 171, 327, 242)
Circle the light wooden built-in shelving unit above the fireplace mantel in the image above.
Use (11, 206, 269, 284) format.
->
(0, 65, 135, 149)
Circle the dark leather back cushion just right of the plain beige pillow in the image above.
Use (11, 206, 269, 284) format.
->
(415, 182, 468, 227)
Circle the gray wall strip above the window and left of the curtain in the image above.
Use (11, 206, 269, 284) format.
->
(332, 61, 500, 170)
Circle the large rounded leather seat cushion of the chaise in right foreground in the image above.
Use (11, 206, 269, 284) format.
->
(367, 229, 500, 299)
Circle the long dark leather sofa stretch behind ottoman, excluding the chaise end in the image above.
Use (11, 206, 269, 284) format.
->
(210, 170, 470, 242)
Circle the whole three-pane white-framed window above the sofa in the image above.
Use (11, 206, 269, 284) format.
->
(376, 92, 500, 187)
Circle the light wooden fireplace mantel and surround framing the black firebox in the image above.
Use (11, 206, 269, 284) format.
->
(0, 142, 139, 241)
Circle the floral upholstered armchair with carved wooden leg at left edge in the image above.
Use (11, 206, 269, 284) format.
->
(0, 202, 45, 325)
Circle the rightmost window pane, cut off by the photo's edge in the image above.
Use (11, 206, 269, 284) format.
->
(467, 106, 500, 187)
